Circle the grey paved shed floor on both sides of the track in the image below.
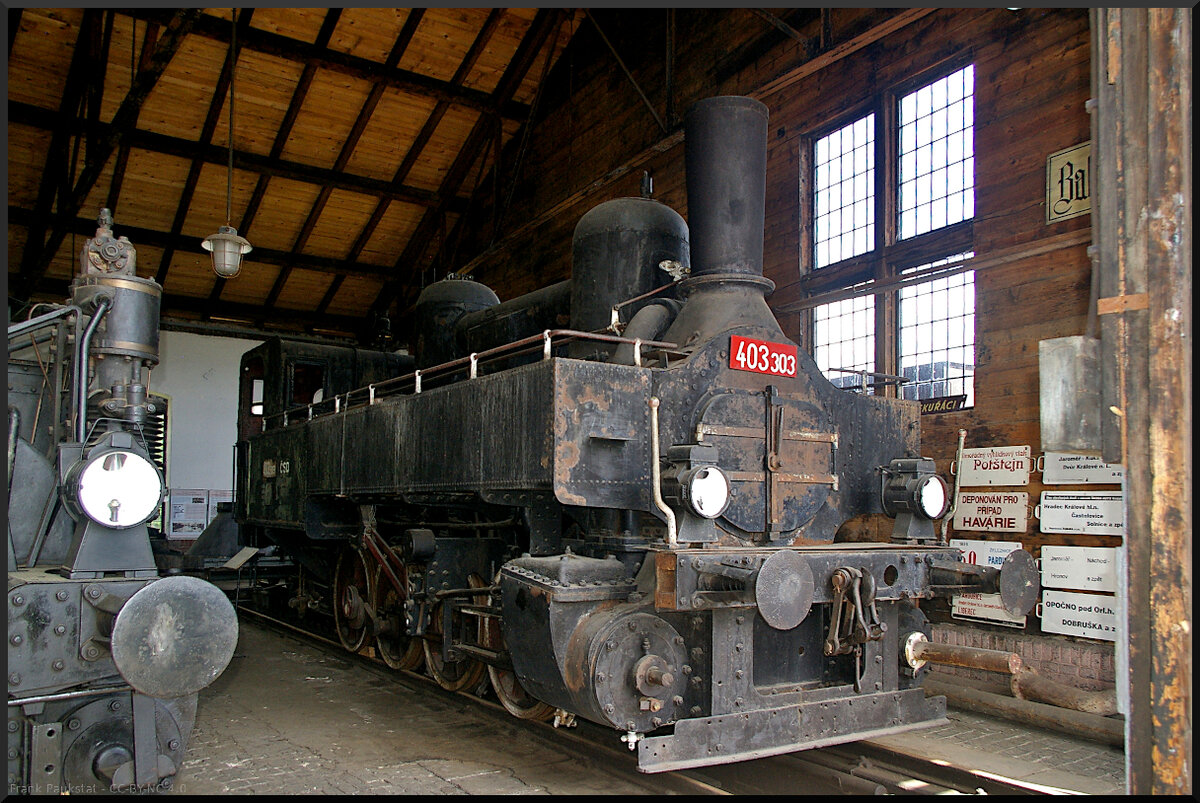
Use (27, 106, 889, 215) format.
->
(175, 617, 1124, 795)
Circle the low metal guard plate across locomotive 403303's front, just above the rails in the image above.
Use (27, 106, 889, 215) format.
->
(637, 688, 946, 773)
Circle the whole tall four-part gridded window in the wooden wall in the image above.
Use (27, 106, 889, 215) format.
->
(805, 65, 974, 407)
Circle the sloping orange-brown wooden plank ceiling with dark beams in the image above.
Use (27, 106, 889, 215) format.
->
(7, 8, 582, 338)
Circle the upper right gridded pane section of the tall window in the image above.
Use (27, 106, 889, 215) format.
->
(899, 65, 974, 239)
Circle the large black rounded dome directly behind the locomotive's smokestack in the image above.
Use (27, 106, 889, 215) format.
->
(571, 198, 690, 340)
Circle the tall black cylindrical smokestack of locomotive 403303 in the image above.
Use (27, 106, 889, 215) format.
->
(684, 97, 767, 276)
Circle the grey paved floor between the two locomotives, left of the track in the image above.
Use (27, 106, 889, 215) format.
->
(174, 618, 667, 795)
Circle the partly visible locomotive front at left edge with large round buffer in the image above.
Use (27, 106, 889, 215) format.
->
(7, 209, 238, 795)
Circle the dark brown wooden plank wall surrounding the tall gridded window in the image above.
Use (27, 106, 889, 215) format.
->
(461, 8, 1104, 607)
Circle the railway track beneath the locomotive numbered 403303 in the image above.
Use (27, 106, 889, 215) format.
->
(229, 605, 1056, 795)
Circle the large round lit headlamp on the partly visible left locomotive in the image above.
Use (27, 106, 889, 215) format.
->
(73, 449, 163, 529)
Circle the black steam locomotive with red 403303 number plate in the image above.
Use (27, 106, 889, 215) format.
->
(235, 97, 1036, 772)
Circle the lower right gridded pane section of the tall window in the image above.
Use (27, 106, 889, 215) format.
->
(899, 252, 974, 407)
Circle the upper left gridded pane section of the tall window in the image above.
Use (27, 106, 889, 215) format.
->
(812, 114, 875, 268)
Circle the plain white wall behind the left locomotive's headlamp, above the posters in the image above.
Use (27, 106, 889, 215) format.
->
(150, 331, 262, 491)
